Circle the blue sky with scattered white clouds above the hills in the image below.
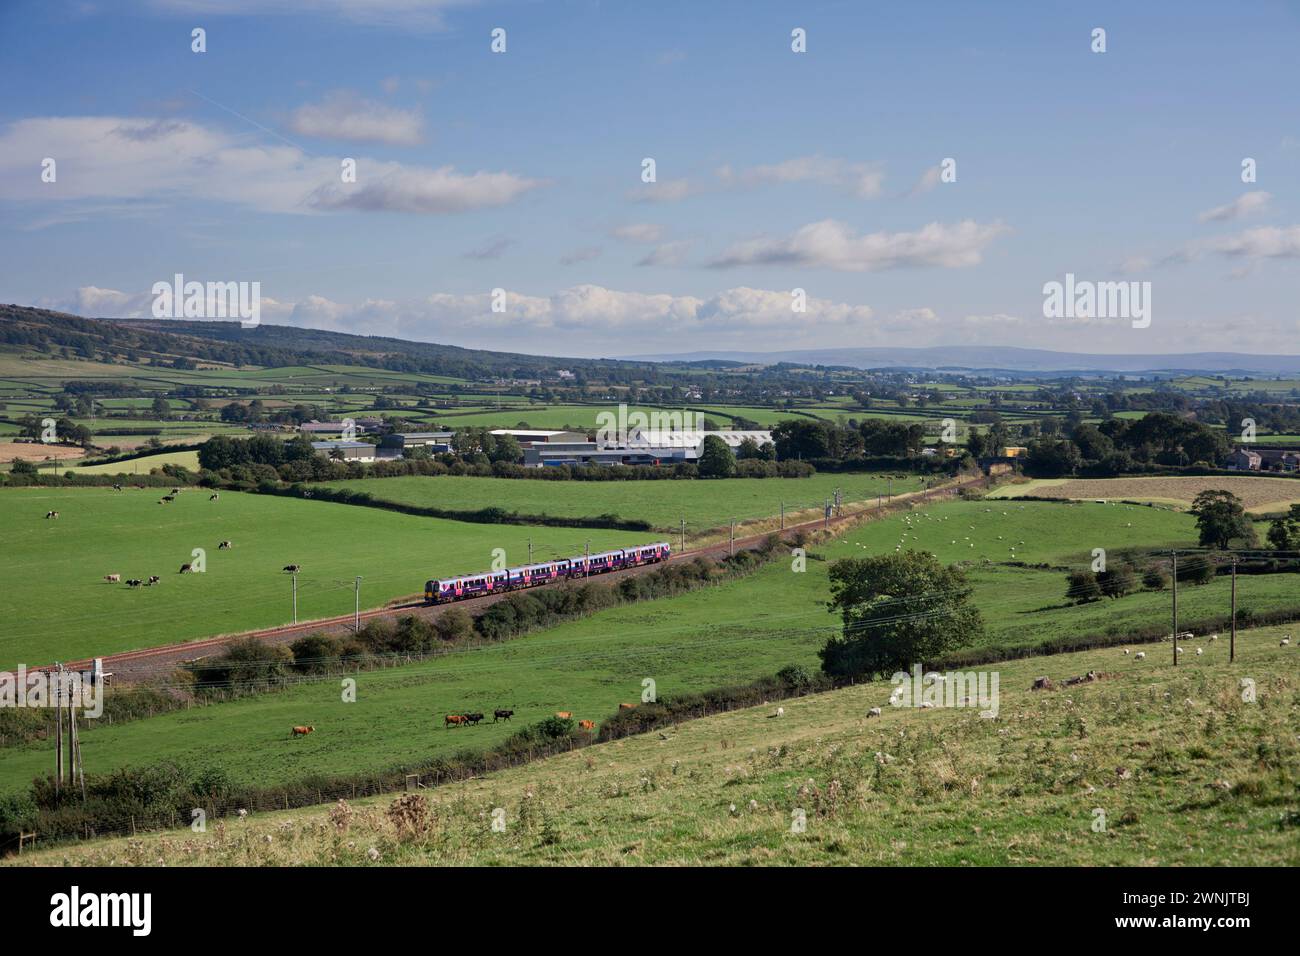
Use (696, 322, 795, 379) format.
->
(0, 0, 1300, 355)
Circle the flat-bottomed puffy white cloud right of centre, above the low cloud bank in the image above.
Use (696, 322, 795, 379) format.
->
(712, 220, 1009, 272)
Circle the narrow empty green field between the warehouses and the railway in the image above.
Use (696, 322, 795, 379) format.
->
(318, 473, 923, 533)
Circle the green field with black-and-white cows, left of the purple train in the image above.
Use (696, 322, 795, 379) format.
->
(0, 488, 653, 669)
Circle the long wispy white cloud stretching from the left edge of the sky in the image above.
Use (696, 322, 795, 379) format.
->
(0, 117, 543, 213)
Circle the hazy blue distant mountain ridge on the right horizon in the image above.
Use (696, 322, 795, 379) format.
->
(624, 346, 1300, 376)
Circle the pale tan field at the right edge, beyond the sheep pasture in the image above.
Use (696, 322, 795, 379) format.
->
(988, 475, 1300, 512)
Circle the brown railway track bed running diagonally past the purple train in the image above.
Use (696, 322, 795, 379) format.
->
(48, 476, 987, 683)
